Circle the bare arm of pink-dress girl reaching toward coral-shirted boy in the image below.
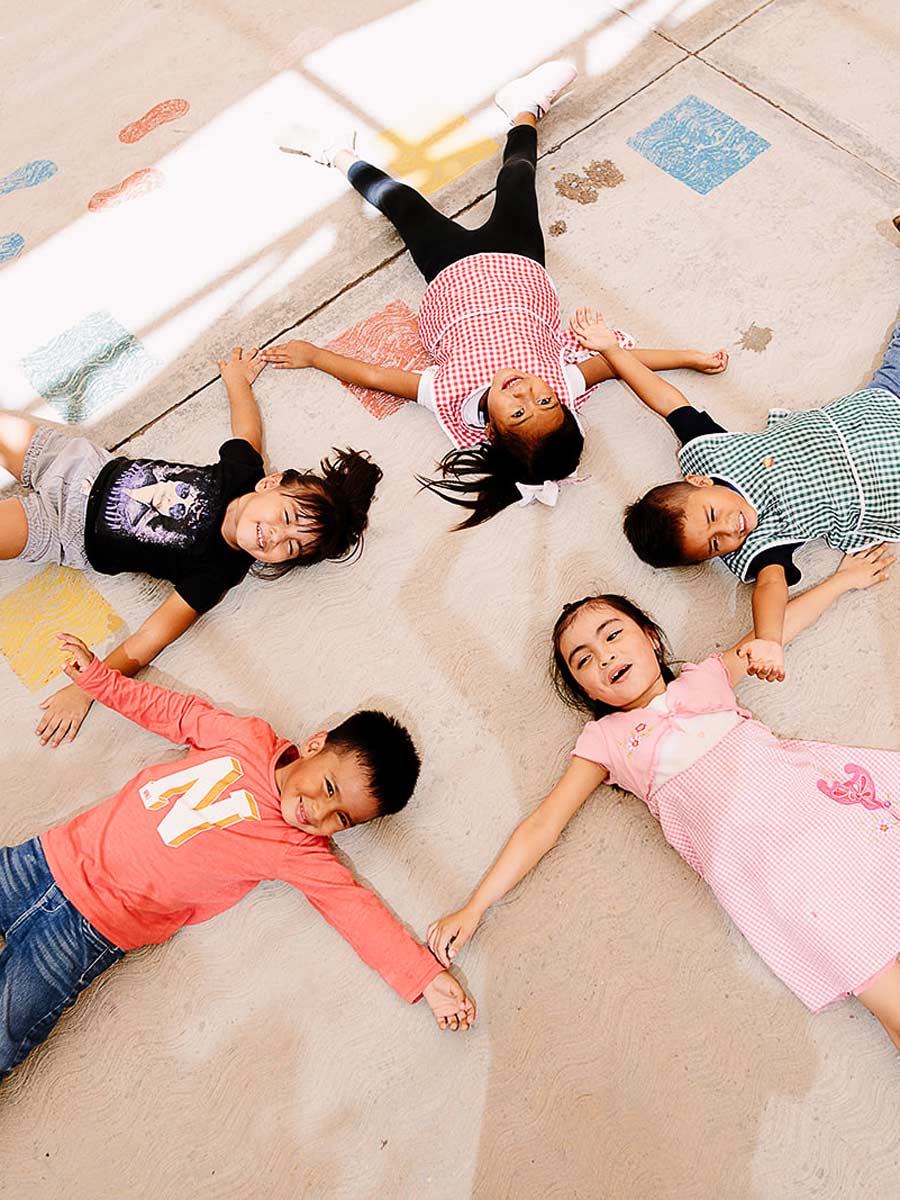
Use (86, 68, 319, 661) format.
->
(428, 758, 608, 966)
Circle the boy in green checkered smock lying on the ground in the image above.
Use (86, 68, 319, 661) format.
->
(571, 308, 900, 680)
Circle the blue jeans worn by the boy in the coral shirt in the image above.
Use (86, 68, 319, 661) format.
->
(0, 838, 125, 1079)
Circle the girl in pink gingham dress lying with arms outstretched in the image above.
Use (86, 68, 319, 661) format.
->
(428, 546, 900, 1049)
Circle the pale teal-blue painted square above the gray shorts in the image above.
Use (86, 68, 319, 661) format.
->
(22, 312, 160, 425)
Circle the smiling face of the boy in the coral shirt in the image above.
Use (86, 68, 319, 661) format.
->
(275, 733, 380, 838)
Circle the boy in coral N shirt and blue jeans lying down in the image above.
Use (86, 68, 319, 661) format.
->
(0, 634, 475, 1078)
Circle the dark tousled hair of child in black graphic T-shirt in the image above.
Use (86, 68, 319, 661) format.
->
(253, 448, 382, 580)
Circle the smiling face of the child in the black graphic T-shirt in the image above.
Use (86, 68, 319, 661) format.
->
(222, 474, 317, 563)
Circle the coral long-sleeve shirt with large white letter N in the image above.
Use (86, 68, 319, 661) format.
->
(41, 658, 442, 1002)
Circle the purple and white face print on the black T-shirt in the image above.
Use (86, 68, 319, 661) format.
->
(97, 460, 222, 550)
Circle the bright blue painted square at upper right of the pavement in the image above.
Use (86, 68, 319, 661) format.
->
(628, 96, 769, 196)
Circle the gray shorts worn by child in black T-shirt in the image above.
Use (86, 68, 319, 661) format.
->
(19, 425, 113, 570)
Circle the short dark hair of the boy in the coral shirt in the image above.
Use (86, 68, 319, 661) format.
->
(328, 709, 421, 817)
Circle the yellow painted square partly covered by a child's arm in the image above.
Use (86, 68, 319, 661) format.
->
(0, 566, 122, 691)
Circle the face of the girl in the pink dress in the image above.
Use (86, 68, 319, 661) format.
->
(558, 600, 666, 709)
